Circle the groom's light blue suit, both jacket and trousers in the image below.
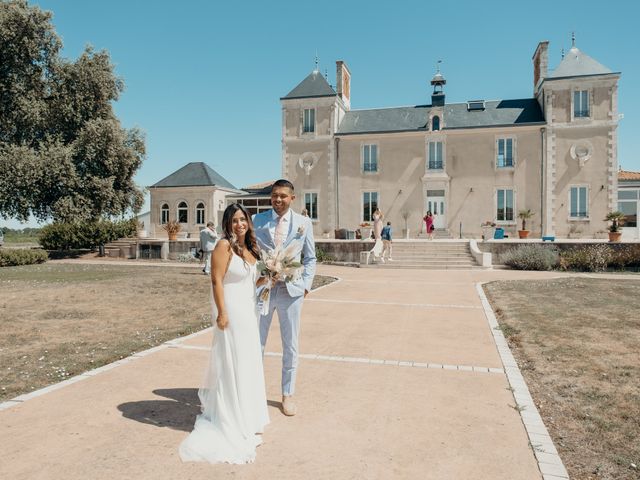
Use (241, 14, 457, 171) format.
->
(253, 210, 316, 395)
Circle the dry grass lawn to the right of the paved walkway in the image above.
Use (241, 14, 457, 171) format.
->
(485, 277, 640, 480)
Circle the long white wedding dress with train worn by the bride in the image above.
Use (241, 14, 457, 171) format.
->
(180, 253, 269, 463)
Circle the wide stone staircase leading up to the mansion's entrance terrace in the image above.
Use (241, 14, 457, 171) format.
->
(360, 240, 482, 270)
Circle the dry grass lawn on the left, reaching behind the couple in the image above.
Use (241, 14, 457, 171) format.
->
(0, 263, 332, 401)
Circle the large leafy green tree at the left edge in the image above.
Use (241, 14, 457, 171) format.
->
(0, 0, 145, 222)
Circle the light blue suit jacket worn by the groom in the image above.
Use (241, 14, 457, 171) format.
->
(253, 210, 316, 297)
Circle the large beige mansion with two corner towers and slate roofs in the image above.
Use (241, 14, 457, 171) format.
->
(281, 42, 620, 238)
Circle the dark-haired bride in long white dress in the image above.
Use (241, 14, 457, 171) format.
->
(180, 203, 269, 463)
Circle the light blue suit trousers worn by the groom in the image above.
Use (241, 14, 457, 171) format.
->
(260, 282, 304, 395)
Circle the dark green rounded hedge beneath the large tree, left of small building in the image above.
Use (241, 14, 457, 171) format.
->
(39, 218, 137, 250)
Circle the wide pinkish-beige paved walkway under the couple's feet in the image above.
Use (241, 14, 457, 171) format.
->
(0, 266, 558, 480)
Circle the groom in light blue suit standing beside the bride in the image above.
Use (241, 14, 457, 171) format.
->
(253, 179, 316, 416)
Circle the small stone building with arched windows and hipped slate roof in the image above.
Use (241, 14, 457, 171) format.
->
(149, 162, 244, 239)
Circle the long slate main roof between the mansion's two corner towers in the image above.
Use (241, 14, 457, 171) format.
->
(336, 98, 545, 135)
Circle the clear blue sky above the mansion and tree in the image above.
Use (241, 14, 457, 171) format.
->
(5, 0, 640, 229)
